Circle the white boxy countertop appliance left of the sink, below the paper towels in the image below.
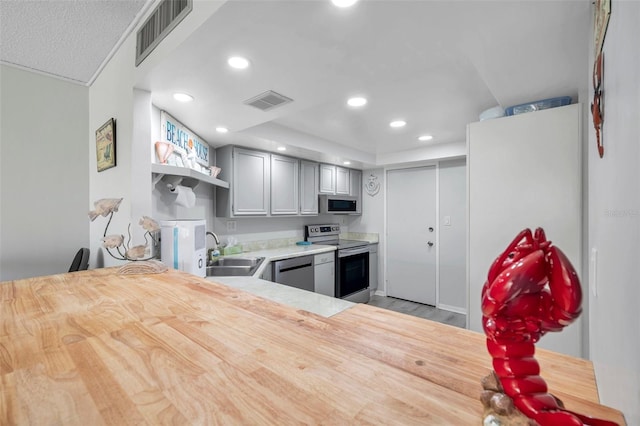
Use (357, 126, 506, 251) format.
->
(160, 219, 207, 277)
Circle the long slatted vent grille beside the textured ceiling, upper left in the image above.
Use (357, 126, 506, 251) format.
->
(136, 0, 193, 66)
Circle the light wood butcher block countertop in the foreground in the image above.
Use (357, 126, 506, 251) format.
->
(0, 268, 624, 425)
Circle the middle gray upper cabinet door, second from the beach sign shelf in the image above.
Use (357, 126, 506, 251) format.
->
(271, 155, 300, 216)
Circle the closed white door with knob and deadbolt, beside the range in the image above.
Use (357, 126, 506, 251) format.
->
(387, 166, 436, 306)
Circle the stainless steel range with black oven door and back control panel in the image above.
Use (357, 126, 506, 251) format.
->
(304, 223, 369, 303)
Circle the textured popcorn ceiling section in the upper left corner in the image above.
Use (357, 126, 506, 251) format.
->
(0, 0, 148, 84)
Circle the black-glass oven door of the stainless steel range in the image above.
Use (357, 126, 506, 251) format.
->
(336, 246, 369, 303)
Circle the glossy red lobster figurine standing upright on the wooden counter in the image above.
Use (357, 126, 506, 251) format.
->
(482, 228, 616, 426)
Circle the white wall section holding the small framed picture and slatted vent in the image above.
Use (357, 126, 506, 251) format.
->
(88, 1, 223, 267)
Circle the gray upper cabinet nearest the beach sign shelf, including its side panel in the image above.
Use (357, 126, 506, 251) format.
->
(216, 146, 271, 217)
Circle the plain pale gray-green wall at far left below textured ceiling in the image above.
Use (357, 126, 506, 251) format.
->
(0, 65, 90, 280)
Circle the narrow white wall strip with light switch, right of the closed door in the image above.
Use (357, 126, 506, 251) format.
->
(438, 158, 467, 314)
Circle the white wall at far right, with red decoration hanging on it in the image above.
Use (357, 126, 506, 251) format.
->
(588, 1, 640, 425)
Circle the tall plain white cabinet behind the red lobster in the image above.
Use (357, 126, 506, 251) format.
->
(467, 104, 588, 356)
